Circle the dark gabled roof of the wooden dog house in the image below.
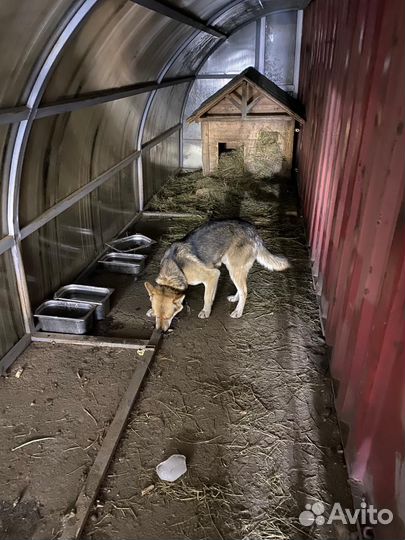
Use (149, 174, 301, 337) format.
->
(187, 67, 305, 124)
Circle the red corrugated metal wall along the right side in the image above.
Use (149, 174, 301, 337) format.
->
(298, 0, 405, 540)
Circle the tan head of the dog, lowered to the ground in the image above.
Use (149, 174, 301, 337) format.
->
(145, 282, 185, 332)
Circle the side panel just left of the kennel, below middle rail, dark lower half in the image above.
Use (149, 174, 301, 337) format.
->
(142, 132, 180, 203)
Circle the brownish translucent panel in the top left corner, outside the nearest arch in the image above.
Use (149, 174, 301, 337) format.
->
(0, 0, 72, 107)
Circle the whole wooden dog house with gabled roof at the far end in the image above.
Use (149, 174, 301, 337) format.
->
(187, 67, 305, 176)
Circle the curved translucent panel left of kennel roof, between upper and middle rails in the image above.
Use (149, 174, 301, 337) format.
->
(142, 83, 188, 143)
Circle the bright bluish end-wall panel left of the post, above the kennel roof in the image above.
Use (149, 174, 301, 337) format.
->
(200, 22, 256, 75)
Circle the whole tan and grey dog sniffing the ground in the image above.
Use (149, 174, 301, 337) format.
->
(145, 219, 290, 332)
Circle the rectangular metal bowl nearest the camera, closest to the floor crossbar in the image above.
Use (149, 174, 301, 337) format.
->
(35, 300, 96, 334)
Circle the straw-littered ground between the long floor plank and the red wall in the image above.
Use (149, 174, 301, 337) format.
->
(86, 156, 350, 540)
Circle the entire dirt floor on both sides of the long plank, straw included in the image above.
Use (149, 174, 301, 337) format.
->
(0, 169, 351, 540)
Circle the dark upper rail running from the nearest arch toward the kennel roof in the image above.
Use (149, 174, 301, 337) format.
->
(35, 76, 194, 119)
